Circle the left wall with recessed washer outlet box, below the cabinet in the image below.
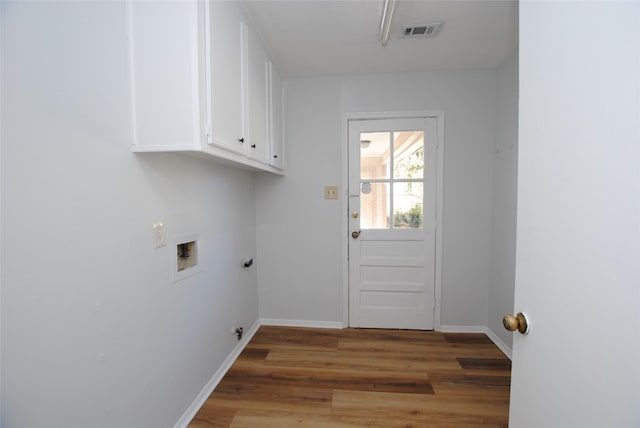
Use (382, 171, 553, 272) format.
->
(1, 2, 258, 428)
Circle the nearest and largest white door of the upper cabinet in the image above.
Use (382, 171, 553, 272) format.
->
(210, 1, 246, 153)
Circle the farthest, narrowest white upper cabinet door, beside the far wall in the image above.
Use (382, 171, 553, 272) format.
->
(269, 62, 285, 169)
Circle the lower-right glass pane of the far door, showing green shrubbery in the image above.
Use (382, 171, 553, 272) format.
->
(393, 182, 423, 229)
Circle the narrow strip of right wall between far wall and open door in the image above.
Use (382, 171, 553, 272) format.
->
(488, 54, 518, 348)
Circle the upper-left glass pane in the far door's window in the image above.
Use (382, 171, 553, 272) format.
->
(360, 132, 391, 180)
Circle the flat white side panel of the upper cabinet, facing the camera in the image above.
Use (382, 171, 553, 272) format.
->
(127, 1, 208, 151)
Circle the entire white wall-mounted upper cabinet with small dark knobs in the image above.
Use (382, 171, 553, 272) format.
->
(127, 0, 282, 174)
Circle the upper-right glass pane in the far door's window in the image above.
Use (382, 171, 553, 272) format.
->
(393, 131, 424, 179)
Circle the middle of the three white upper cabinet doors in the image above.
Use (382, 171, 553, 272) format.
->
(246, 27, 269, 164)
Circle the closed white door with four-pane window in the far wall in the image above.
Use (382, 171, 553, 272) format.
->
(348, 117, 438, 329)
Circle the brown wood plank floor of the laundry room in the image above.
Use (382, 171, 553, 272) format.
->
(189, 326, 511, 428)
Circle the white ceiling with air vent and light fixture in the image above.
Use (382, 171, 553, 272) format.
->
(241, 0, 518, 77)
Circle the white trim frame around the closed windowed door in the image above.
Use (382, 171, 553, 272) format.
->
(340, 110, 444, 331)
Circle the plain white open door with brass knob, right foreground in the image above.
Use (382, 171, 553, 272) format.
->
(509, 1, 640, 428)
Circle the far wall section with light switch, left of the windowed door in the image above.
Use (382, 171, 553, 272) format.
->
(255, 78, 342, 323)
